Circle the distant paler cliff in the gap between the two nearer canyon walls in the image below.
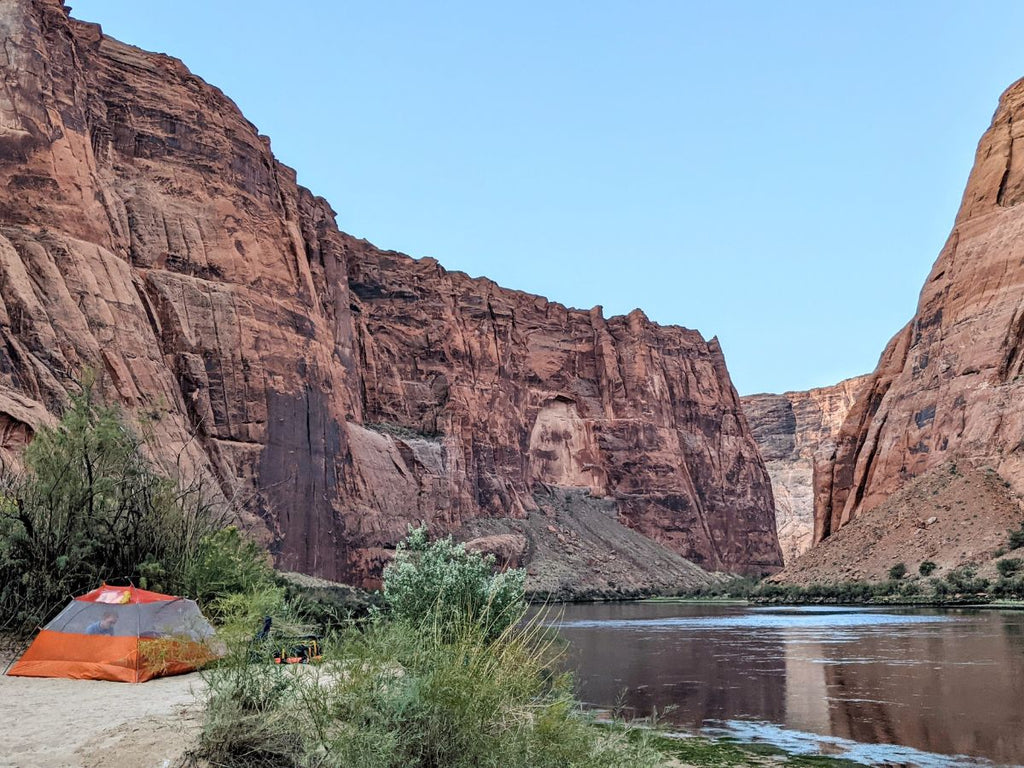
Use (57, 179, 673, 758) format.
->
(740, 376, 868, 564)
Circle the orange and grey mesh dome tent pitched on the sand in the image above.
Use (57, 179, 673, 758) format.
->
(7, 585, 214, 683)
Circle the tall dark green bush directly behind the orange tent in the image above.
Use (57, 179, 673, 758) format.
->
(0, 385, 218, 631)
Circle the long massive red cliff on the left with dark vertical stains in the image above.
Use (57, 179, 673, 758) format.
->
(0, 0, 780, 582)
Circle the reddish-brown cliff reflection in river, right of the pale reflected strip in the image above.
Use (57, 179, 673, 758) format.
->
(815, 614, 1024, 763)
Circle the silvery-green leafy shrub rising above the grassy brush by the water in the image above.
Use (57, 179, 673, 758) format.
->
(384, 526, 526, 637)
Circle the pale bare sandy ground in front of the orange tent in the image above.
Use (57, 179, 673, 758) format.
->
(0, 662, 204, 768)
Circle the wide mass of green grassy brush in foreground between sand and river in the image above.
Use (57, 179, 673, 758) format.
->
(201, 620, 660, 768)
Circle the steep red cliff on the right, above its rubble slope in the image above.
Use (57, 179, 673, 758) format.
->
(815, 75, 1024, 540)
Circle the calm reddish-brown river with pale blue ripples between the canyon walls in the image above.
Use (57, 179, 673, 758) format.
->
(548, 602, 1024, 768)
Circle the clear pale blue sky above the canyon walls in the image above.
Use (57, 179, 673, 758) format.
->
(71, 0, 1024, 394)
